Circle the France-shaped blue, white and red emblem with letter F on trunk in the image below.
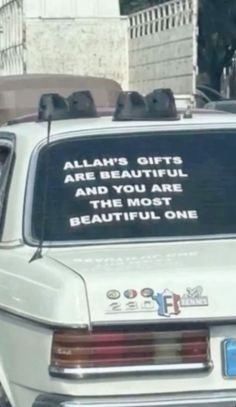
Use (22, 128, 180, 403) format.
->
(152, 289, 181, 317)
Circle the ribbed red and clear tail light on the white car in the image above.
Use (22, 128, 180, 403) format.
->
(50, 329, 210, 380)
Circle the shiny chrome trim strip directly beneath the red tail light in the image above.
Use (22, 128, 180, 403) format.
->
(49, 361, 213, 379)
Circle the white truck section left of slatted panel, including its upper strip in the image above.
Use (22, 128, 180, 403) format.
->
(0, 0, 128, 88)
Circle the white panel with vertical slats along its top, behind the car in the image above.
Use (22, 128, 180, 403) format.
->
(129, 0, 197, 94)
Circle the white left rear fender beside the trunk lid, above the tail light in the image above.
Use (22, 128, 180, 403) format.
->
(0, 247, 89, 326)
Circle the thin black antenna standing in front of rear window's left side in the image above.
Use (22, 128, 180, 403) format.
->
(29, 115, 52, 263)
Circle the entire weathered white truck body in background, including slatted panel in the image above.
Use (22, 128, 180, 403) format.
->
(0, 0, 197, 93)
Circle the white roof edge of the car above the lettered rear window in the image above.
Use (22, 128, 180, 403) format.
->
(0, 110, 236, 148)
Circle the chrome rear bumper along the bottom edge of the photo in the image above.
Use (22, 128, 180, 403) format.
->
(33, 390, 236, 407)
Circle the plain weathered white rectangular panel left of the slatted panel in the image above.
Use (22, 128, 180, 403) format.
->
(26, 17, 128, 89)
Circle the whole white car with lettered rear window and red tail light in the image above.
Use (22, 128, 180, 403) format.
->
(0, 87, 236, 407)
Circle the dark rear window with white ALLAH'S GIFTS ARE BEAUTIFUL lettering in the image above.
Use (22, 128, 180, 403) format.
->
(30, 131, 236, 242)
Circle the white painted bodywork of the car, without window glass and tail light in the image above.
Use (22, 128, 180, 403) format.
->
(0, 112, 236, 407)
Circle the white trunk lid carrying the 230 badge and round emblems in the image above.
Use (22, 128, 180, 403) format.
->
(48, 239, 236, 324)
